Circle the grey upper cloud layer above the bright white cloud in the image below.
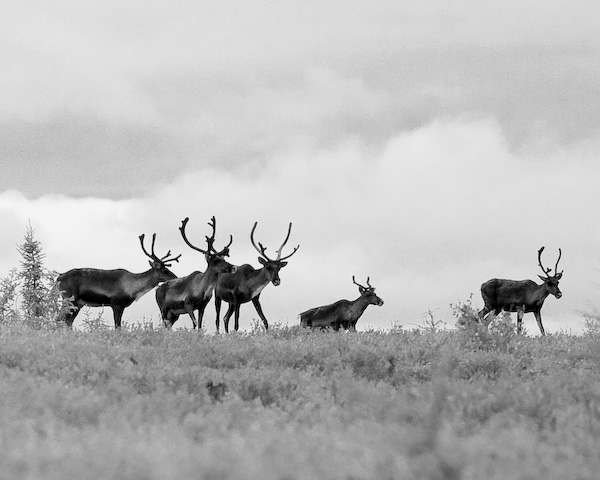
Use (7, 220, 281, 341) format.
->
(0, 0, 600, 199)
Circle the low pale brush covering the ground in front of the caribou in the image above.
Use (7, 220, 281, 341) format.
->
(0, 324, 600, 480)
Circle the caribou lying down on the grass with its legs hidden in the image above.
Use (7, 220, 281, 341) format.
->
(300, 276, 383, 331)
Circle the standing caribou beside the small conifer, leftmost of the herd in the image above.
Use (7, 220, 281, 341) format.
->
(56, 234, 181, 329)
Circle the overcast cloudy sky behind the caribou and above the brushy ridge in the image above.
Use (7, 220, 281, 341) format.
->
(0, 0, 600, 334)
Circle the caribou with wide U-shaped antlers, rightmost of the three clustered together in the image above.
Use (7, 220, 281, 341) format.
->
(215, 222, 300, 333)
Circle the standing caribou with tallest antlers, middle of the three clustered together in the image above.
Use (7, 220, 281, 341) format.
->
(156, 216, 237, 329)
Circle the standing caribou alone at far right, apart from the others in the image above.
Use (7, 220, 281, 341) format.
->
(479, 247, 563, 335)
